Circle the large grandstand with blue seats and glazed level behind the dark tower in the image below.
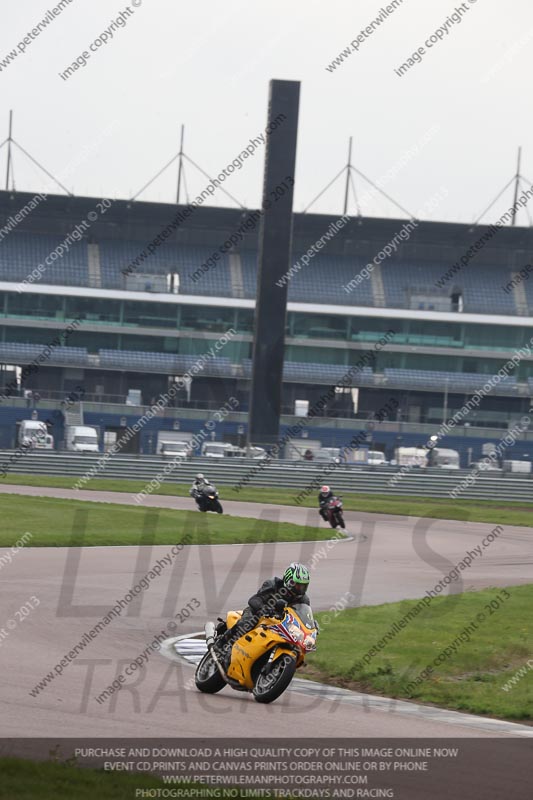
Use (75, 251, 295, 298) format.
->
(0, 192, 533, 462)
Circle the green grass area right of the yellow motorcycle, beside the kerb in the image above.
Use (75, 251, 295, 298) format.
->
(303, 585, 533, 724)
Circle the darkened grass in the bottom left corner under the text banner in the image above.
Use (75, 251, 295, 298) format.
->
(0, 758, 254, 800)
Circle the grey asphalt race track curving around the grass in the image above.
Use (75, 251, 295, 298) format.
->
(0, 478, 533, 738)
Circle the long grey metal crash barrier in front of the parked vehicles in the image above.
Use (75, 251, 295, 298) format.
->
(0, 450, 533, 502)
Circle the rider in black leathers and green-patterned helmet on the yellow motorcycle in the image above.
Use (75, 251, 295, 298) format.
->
(217, 561, 311, 655)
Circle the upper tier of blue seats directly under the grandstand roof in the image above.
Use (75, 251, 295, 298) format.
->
(0, 231, 533, 315)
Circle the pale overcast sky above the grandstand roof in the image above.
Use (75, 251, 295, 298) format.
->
(0, 0, 533, 225)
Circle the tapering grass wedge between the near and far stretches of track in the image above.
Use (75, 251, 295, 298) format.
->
(0, 494, 333, 547)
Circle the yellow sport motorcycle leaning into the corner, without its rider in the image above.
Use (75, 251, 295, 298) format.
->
(195, 603, 318, 703)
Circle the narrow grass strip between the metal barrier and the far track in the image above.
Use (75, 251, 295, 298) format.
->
(3, 474, 533, 526)
